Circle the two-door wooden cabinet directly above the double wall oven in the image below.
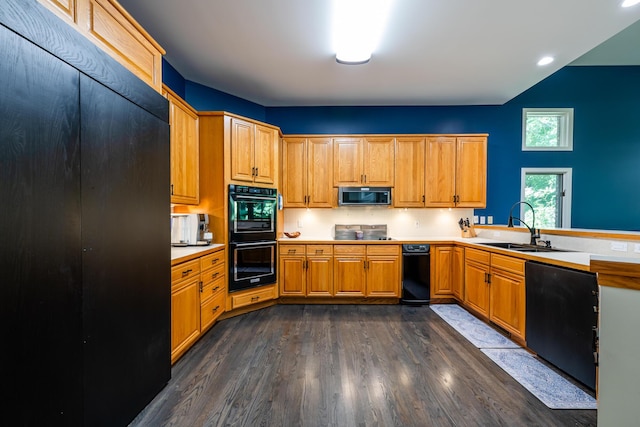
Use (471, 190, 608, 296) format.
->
(230, 118, 278, 184)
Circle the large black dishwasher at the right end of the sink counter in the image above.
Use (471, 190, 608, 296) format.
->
(525, 261, 598, 389)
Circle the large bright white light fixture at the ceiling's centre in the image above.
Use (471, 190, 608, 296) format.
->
(333, 0, 392, 65)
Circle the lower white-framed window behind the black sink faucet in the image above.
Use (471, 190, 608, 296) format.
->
(520, 168, 571, 228)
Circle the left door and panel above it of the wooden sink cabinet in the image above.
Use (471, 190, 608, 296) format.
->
(464, 248, 491, 319)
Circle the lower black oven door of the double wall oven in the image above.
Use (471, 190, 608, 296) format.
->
(229, 241, 277, 292)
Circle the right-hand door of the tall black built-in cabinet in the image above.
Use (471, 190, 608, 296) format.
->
(80, 76, 171, 426)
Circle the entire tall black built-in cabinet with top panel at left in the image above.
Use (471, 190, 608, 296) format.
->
(0, 0, 171, 426)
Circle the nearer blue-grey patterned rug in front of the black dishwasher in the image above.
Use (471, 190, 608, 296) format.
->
(480, 348, 597, 409)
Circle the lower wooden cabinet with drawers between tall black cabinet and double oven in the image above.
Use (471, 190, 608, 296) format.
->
(171, 248, 227, 363)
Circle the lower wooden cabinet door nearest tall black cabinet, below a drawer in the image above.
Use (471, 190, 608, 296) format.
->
(171, 276, 200, 363)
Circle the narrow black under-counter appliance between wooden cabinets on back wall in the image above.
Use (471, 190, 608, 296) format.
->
(400, 244, 431, 305)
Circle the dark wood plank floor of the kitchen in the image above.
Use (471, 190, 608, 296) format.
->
(131, 305, 596, 427)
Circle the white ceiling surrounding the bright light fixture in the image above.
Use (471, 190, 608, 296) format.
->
(120, 0, 640, 106)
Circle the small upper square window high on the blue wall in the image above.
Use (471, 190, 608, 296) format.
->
(522, 108, 573, 151)
